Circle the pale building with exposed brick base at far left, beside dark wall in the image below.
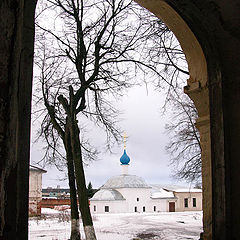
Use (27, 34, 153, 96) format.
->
(29, 165, 47, 216)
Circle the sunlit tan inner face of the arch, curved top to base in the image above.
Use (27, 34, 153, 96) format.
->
(137, 0, 212, 239)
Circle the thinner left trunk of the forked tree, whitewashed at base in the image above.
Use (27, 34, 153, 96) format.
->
(64, 126, 81, 240)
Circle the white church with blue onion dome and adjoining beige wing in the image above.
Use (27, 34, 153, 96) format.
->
(90, 149, 202, 213)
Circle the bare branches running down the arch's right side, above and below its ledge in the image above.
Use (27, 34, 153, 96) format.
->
(137, 16, 201, 184)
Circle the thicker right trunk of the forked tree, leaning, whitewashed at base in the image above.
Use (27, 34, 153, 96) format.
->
(70, 119, 96, 240)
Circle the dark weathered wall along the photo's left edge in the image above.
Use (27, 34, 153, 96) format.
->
(0, 0, 36, 239)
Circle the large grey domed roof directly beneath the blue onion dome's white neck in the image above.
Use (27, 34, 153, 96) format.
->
(101, 175, 151, 189)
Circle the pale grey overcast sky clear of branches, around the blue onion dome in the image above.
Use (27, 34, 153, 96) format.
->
(31, 83, 189, 188)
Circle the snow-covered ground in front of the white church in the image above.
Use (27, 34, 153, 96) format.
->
(29, 209, 202, 240)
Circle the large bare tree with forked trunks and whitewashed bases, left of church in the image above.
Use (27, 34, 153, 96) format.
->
(35, 0, 171, 239)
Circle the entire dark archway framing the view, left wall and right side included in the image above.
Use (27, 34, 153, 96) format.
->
(0, 0, 240, 240)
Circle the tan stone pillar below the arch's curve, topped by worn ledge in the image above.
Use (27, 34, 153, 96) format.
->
(184, 78, 212, 240)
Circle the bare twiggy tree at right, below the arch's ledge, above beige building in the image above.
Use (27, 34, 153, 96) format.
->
(165, 91, 201, 184)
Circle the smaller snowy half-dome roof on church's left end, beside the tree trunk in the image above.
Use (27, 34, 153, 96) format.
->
(90, 189, 126, 201)
